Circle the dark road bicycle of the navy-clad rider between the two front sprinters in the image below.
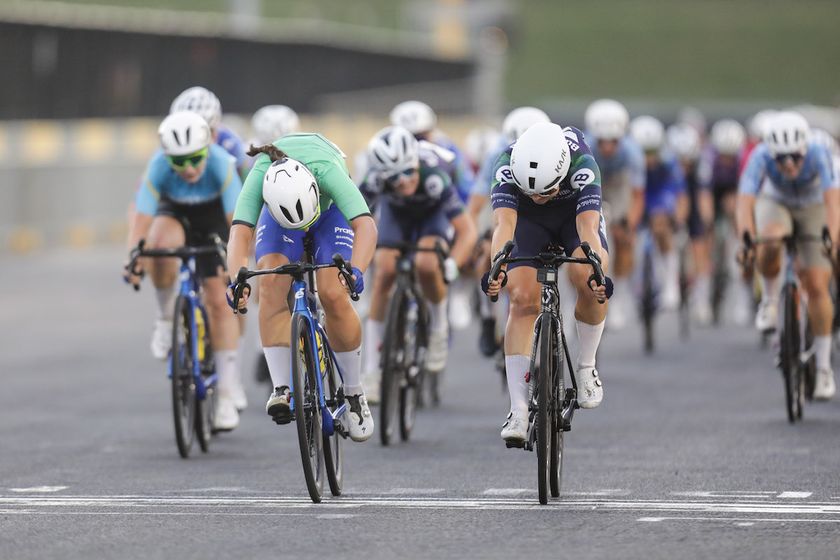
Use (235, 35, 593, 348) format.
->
(379, 242, 448, 445)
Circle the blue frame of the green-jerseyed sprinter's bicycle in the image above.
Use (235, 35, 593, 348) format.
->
(289, 280, 347, 436)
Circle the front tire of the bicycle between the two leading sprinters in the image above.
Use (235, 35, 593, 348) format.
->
(379, 287, 407, 446)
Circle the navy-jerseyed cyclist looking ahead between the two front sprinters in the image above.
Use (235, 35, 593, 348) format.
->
(361, 126, 476, 396)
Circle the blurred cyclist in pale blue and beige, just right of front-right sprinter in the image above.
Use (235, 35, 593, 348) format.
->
(584, 99, 645, 329)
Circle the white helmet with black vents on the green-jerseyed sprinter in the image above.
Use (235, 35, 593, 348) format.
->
(263, 157, 321, 229)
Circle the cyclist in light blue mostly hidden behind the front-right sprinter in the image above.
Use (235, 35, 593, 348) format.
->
(467, 107, 551, 357)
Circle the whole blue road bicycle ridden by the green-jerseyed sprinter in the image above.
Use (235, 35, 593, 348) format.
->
(233, 234, 359, 503)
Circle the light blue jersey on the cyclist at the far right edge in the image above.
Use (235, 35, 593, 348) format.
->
(738, 142, 840, 208)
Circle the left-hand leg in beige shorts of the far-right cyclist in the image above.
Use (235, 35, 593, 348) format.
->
(755, 196, 793, 331)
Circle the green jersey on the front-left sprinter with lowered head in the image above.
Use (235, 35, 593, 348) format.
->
(233, 133, 370, 227)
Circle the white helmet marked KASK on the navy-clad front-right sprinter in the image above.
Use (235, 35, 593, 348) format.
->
(510, 123, 572, 195)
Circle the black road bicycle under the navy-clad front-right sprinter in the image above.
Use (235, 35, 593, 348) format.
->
(490, 241, 605, 504)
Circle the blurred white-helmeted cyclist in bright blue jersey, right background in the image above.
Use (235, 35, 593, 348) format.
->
(630, 115, 688, 310)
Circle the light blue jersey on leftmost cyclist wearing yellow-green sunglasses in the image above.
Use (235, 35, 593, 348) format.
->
(136, 144, 242, 216)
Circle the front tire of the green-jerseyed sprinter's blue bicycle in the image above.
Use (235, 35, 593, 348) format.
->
(291, 314, 324, 504)
